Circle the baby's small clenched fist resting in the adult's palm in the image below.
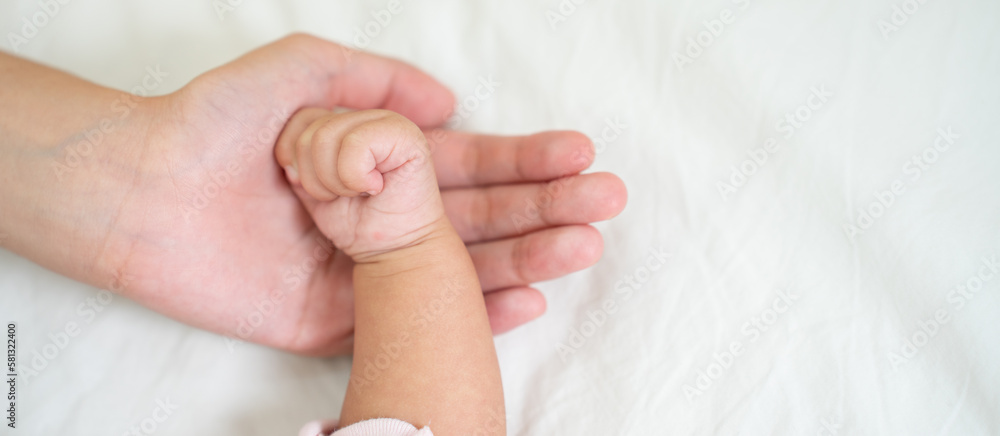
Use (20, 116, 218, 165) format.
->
(275, 109, 450, 262)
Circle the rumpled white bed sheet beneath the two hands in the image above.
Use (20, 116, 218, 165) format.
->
(0, 0, 1000, 436)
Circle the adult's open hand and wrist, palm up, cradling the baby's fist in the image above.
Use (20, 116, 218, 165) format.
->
(0, 35, 626, 355)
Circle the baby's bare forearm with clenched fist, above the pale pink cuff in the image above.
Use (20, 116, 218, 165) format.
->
(275, 109, 506, 436)
